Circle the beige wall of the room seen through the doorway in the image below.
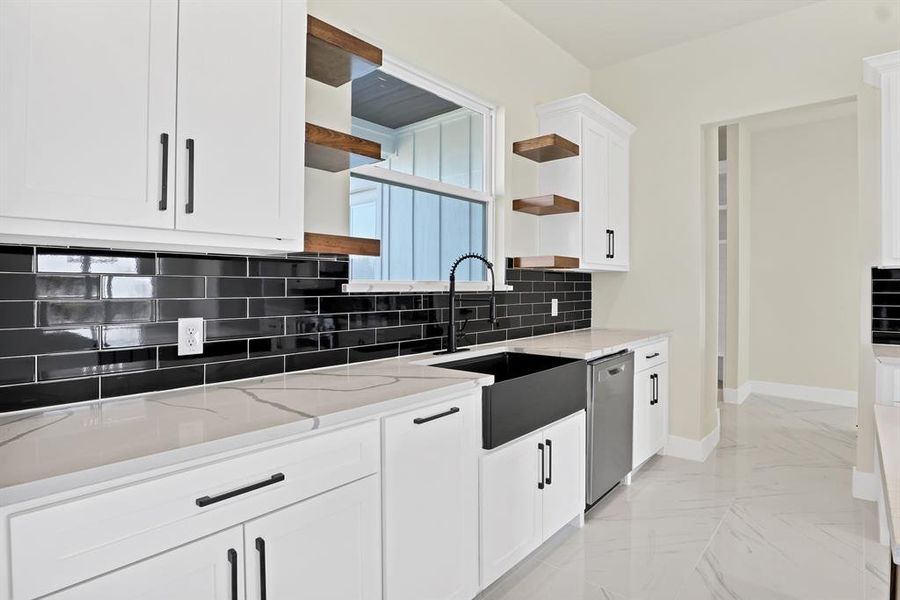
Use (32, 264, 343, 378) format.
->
(749, 115, 860, 392)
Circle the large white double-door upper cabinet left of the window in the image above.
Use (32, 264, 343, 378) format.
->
(0, 0, 306, 251)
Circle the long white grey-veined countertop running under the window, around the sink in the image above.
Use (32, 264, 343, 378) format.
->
(0, 329, 667, 506)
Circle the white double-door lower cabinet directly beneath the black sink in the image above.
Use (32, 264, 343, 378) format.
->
(480, 411, 585, 588)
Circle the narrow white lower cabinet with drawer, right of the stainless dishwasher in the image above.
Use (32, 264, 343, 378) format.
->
(631, 341, 669, 468)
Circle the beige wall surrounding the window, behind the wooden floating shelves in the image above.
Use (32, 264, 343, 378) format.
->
(305, 0, 590, 256)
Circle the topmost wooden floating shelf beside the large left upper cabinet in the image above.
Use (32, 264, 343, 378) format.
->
(306, 16, 382, 87)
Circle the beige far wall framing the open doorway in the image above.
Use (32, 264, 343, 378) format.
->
(591, 0, 900, 440)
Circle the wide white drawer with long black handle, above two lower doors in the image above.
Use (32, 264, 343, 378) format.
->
(9, 421, 380, 600)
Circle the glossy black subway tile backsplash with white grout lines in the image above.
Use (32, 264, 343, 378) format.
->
(0, 245, 592, 412)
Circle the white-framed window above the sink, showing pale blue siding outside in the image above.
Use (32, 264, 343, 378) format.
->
(350, 60, 494, 283)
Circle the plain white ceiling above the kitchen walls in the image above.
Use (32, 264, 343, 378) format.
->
(502, 0, 819, 69)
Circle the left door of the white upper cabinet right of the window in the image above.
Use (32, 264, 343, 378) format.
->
(581, 119, 612, 268)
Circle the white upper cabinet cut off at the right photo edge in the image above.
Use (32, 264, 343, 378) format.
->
(864, 50, 900, 267)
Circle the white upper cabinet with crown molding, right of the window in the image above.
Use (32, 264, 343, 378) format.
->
(538, 94, 634, 271)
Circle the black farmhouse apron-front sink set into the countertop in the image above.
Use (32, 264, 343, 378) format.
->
(435, 352, 587, 449)
